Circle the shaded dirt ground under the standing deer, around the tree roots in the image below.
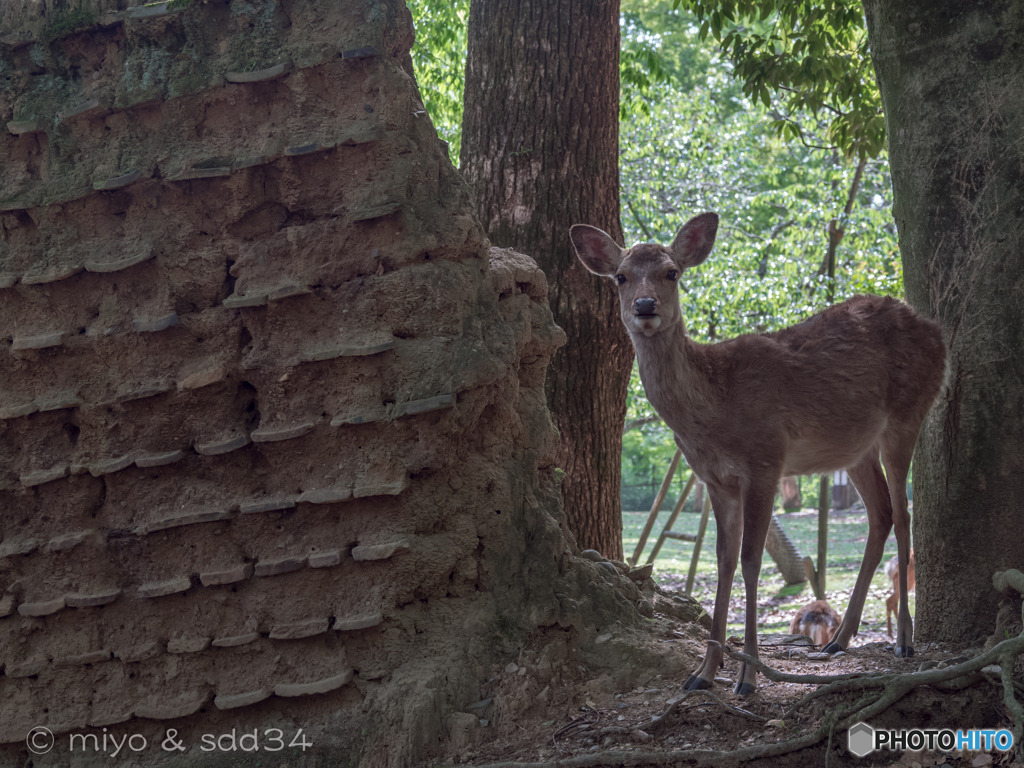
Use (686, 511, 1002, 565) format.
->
(453, 585, 1024, 768)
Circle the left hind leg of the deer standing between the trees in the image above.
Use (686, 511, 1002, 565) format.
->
(822, 446, 893, 653)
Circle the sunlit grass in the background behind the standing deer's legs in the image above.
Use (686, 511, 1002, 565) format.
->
(623, 507, 914, 645)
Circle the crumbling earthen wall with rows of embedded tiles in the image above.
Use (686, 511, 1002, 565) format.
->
(0, 0, 655, 766)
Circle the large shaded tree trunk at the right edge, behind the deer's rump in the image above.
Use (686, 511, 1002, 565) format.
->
(864, 0, 1024, 641)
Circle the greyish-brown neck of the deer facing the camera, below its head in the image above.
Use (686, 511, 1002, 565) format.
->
(631, 321, 713, 440)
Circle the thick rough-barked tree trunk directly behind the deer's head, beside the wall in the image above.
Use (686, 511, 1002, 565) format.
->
(461, 0, 633, 558)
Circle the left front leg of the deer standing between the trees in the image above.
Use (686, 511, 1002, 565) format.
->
(684, 484, 743, 690)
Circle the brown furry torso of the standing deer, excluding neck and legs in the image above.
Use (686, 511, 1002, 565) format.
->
(684, 296, 945, 474)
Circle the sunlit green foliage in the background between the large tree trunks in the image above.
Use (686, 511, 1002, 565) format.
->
(412, 0, 903, 518)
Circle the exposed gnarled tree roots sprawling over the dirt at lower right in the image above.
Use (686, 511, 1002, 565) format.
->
(468, 570, 1024, 768)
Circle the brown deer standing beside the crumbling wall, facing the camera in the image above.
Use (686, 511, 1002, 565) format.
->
(569, 212, 946, 696)
